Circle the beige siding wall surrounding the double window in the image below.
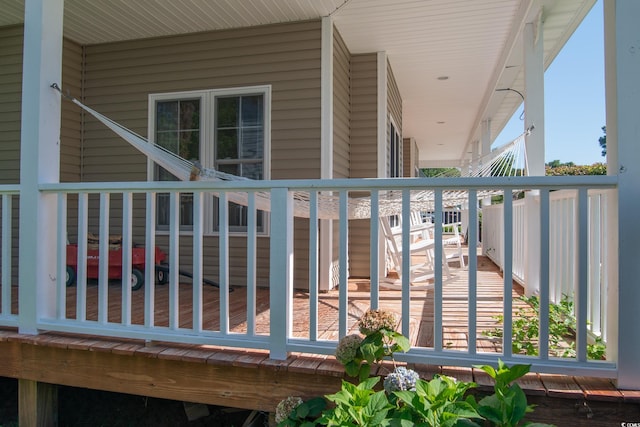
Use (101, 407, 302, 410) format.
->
(83, 21, 321, 286)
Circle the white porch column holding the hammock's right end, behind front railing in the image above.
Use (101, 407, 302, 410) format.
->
(523, 15, 545, 295)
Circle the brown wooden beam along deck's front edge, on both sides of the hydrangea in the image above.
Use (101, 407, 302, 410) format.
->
(0, 330, 640, 426)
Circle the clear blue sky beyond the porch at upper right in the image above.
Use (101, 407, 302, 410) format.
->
(492, 0, 606, 165)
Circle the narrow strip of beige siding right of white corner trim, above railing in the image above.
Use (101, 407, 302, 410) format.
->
(333, 29, 351, 178)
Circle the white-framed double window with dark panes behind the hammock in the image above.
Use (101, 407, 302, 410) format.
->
(149, 86, 270, 233)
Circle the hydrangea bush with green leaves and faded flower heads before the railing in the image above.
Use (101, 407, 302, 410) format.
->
(276, 310, 545, 427)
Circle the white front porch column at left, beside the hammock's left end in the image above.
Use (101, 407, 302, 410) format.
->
(18, 0, 64, 334)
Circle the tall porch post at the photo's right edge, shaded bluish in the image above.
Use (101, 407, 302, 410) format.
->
(604, 0, 640, 389)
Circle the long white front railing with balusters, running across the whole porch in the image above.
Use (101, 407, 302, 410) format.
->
(0, 176, 616, 378)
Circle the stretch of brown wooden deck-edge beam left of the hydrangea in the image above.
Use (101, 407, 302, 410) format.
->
(0, 331, 341, 411)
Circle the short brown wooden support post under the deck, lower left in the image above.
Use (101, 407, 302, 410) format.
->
(18, 379, 58, 427)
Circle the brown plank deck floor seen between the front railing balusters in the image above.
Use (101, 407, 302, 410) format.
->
(36, 257, 523, 352)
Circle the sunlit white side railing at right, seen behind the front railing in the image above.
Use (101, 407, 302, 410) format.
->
(482, 189, 613, 342)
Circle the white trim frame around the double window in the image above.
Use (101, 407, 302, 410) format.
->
(147, 85, 271, 237)
